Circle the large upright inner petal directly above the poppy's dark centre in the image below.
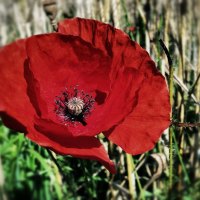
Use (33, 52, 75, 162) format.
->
(27, 34, 111, 112)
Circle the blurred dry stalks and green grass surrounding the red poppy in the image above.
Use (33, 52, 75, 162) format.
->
(0, 0, 200, 200)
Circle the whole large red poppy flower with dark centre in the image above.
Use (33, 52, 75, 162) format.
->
(0, 18, 170, 173)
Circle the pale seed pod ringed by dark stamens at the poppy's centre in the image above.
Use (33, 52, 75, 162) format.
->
(55, 87, 95, 126)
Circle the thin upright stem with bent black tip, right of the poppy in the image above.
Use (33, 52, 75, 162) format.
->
(159, 39, 174, 189)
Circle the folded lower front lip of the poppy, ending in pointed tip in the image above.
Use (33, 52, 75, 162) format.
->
(26, 124, 116, 174)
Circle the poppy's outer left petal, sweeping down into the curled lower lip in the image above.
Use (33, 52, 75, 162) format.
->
(0, 40, 115, 173)
